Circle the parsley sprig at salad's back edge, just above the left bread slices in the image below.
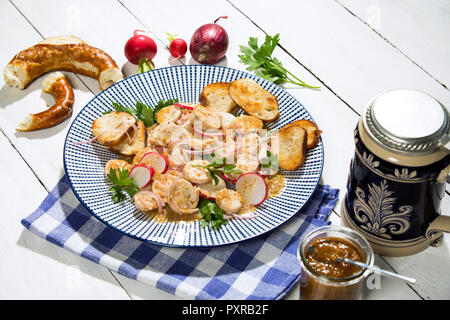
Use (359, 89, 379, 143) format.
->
(103, 99, 178, 127)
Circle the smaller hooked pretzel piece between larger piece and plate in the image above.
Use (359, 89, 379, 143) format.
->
(17, 72, 74, 131)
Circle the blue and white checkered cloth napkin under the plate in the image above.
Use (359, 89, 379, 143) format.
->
(22, 176, 339, 299)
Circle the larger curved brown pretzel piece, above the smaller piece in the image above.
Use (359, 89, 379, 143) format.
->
(4, 36, 123, 90)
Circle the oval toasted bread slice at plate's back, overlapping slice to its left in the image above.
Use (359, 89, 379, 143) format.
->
(228, 79, 280, 122)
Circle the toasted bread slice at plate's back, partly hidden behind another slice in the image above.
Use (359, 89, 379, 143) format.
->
(199, 82, 237, 113)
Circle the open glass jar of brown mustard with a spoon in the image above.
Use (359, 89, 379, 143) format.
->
(297, 226, 374, 300)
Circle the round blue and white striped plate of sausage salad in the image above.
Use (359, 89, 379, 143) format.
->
(64, 65, 324, 247)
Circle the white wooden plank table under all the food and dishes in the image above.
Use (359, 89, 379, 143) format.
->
(0, 0, 450, 299)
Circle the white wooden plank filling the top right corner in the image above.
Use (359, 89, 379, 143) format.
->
(338, 0, 450, 88)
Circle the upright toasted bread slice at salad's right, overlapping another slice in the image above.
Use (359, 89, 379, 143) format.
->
(278, 125, 306, 170)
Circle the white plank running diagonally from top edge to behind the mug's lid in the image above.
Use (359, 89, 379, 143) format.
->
(229, 0, 450, 112)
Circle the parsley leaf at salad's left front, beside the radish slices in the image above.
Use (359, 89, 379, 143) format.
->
(107, 168, 139, 203)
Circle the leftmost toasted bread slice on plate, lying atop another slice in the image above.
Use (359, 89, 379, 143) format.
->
(92, 111, 136, 146)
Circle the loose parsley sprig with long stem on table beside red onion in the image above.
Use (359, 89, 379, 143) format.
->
(239, 33, 320, 89)
